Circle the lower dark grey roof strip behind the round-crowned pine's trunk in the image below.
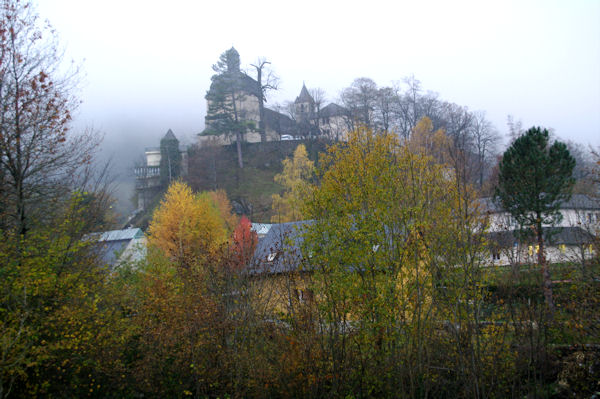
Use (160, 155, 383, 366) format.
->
(486, 227, 594, 248)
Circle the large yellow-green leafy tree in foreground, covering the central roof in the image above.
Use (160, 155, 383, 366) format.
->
(302, 128, 480, 397)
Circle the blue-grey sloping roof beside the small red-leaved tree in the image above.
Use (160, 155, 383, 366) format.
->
(248, 221, 313, 275)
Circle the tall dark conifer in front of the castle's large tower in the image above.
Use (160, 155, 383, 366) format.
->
(205, 47, 255, 169)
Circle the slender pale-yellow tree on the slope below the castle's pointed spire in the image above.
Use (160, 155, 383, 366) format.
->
(271, 144, 314, 223)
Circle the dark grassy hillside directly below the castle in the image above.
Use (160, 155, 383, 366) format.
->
(187, 140, 328, 223)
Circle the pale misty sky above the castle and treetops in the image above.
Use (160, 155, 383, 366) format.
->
(38, 0, 600, 170)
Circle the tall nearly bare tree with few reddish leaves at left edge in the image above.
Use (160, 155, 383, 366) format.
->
(0, 0, 98, 235)
